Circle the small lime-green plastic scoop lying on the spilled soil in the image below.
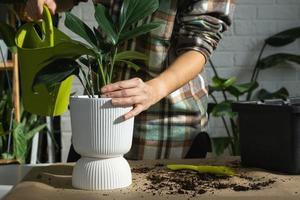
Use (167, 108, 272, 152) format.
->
(167, 164, 235, 176)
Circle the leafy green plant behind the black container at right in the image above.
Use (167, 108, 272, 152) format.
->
(209, 27, 300, 155)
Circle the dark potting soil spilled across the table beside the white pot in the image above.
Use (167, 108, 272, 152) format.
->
(132, 163, 275, 197)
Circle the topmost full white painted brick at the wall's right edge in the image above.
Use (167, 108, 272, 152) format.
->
(257, 5, 299, 20)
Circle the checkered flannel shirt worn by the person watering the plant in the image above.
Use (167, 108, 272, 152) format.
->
(77, 0, 235, 159)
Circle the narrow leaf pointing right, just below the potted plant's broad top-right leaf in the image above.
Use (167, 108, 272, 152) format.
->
(119, 22, 161, 42)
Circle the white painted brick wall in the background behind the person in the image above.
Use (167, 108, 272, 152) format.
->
(61, 0, 300, 159)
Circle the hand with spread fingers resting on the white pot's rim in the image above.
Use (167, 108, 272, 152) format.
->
(101, 78, 161, 120)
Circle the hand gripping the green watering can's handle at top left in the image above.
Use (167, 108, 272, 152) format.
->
(25, 0, 56, 21)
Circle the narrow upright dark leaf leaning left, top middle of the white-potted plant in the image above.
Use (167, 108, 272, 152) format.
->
(95, 4, 118, 44)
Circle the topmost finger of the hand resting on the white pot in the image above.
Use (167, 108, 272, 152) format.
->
(101, 78, 143, 94)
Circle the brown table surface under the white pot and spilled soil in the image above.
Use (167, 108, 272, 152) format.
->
(5, 157, 300, 200)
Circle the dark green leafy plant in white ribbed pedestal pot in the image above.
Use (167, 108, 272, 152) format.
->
(32, 0, 160, 190)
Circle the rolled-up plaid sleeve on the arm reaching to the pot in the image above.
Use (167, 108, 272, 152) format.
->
(174, 0, 235, 61)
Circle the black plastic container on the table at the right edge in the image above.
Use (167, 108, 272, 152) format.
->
(233, 98, 300, 174)
